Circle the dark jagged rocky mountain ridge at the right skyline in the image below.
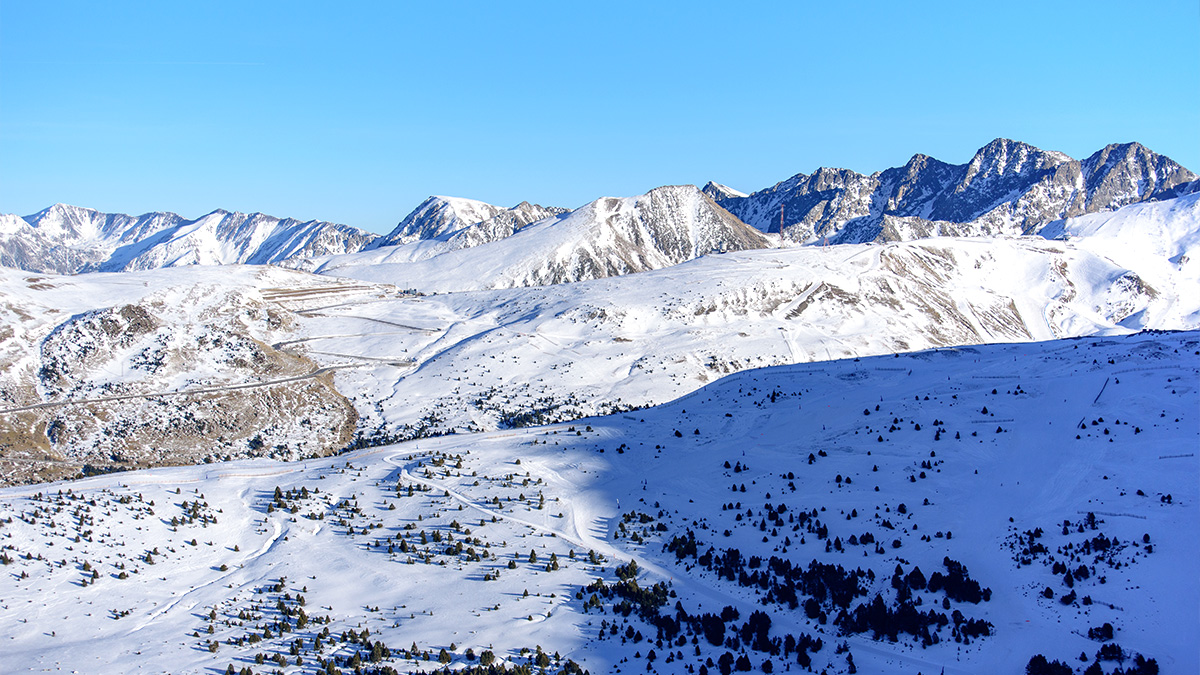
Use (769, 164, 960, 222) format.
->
(706, 138, 1200, 244)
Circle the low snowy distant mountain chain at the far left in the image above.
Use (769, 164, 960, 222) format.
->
(0, 204, 377, 274)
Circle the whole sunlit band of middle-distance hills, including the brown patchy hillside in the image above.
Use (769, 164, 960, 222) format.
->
(0, 191, 1200, 482)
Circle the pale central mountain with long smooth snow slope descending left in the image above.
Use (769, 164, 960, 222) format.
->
(314, 185, 769, 291)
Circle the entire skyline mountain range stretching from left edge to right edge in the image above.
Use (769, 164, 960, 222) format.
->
(0, 138, 1200, 275)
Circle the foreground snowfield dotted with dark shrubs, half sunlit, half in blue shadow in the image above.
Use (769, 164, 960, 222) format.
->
(0, 329, 1200, 674)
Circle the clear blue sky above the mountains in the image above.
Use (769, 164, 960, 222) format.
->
(0, 0, 1200, 232)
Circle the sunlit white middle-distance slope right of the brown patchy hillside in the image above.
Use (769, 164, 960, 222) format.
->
(285, 229, 1200, 432)
